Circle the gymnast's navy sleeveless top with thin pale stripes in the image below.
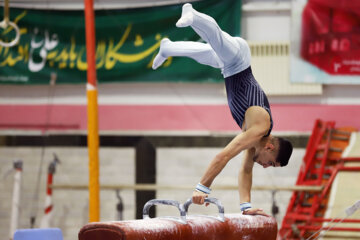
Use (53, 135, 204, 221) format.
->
(225, 67, 273, 136)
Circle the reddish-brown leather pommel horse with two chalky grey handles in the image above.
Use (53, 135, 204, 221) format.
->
(79, 198, 277, 240)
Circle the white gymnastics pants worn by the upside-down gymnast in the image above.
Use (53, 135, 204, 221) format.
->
(154, 4, 251, 77)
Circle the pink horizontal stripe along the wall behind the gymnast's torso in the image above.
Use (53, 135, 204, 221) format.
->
(0, 104, 360, 132)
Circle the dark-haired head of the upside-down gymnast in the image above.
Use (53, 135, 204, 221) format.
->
(253, 135, 293, 168)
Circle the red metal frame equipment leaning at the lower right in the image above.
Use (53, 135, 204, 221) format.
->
(279, 120, 360, 240)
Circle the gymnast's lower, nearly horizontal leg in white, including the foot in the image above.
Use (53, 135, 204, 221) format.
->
(152, 38, 223, 69)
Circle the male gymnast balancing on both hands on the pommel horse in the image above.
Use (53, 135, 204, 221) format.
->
(152, 3, 292, 215)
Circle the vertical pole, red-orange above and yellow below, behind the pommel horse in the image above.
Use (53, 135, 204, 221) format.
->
(84, 0, 100, 222)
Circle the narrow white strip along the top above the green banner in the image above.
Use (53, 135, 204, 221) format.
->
(0, 0, 199, 10)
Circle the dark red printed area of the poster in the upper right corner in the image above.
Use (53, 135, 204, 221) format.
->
(300, 0, 360, 75)
